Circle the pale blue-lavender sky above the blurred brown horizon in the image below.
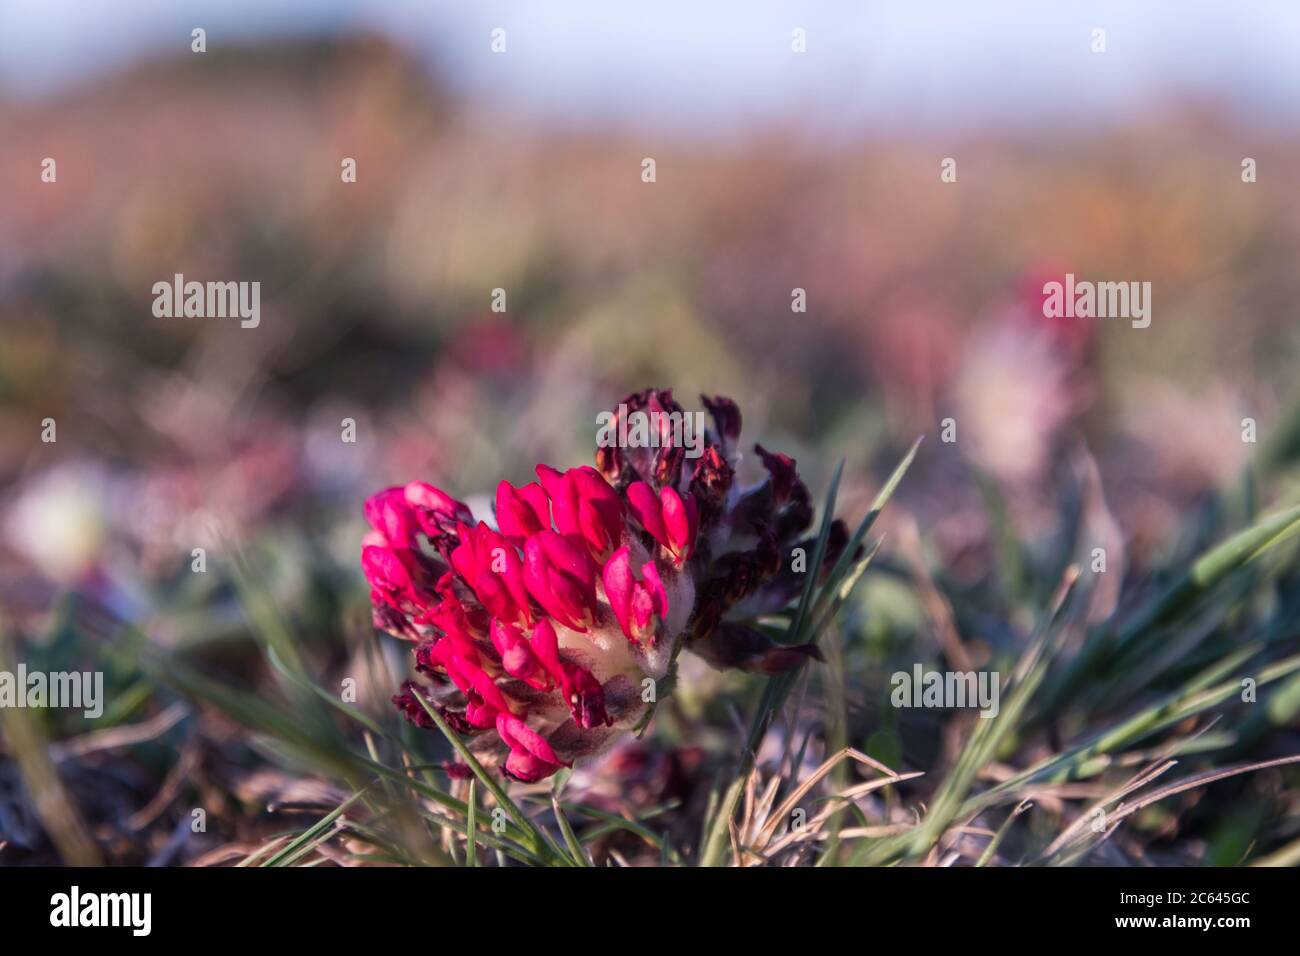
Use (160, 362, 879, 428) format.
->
(0, 0, 1300, 130)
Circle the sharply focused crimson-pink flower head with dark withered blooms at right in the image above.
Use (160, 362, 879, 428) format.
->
(361, 389, 846, 782)
